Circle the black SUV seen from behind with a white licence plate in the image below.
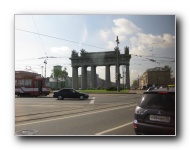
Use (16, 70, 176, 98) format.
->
(133, 88, 176, 135)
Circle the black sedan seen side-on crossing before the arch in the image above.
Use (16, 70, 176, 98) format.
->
(53, 88, 89, 100)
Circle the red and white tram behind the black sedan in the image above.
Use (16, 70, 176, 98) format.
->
(15, 71, 50, 96)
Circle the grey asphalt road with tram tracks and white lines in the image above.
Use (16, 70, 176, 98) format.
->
(15, 94, 141, 136)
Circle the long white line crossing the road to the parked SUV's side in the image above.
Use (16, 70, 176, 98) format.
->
(15, 103, 137, 126)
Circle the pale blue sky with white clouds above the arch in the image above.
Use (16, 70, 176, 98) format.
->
(15, 15, 176, 83)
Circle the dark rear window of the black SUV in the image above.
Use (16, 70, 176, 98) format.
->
(140, 92, 175, 111)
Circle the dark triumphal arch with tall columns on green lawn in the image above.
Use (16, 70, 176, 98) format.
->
(70, 47, 131, 89)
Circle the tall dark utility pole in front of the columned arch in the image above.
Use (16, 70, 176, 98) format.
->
(116, 36, 121, 92)
